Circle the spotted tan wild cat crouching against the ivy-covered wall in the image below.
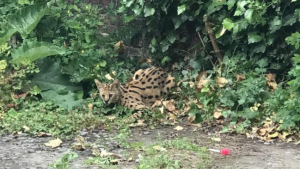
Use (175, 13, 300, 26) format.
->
(95, 67, 175, 110)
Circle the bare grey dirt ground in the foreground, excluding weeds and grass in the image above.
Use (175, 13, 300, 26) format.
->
(0, 126, 300, 169)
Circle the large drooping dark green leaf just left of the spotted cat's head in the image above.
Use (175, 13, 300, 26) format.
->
(31, 58, 83, 110)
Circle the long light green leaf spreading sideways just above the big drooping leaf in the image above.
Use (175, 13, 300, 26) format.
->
(11, 42, 65, 64)
